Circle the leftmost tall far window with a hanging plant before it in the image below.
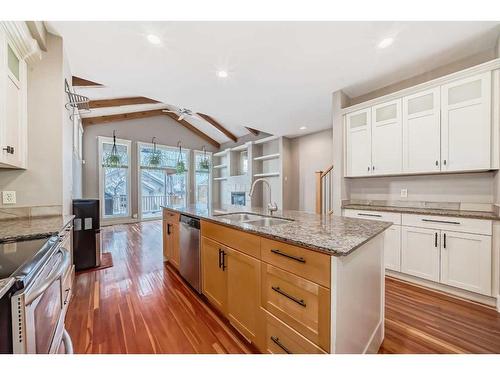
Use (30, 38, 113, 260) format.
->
(98, 137, 131, 219)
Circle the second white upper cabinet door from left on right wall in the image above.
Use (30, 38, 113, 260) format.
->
(371, 99, 402, 175)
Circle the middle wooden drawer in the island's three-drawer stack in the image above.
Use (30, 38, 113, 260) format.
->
(261, 263, 330, 350)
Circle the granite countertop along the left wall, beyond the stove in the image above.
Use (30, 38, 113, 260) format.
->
(0, 215, 75, 243)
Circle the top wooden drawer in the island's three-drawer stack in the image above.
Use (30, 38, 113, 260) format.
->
(261, 238, 331, 288)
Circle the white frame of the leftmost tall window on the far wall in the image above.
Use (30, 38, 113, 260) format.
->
(97, 136, 133, 222)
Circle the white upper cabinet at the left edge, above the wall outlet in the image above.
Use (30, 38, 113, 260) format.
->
(0, 30, 27, 168)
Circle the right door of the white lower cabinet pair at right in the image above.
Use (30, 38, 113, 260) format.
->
(441, 231, 491, 295)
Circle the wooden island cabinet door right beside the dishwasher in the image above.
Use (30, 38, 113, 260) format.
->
(201, 237, 227, 315)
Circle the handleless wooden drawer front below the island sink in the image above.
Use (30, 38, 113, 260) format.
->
(201, 220, 260, 259)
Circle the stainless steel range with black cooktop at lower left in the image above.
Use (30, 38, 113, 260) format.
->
(0, 236, 73, 354)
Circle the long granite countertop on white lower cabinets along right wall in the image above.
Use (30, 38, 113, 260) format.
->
(342, 204, 500, 220)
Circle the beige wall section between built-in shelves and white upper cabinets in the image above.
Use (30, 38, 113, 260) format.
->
(291, 129, 333, 212)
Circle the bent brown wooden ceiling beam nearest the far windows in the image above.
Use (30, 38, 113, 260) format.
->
(82, 109, 220, 148)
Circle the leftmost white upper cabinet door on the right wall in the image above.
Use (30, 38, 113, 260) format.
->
(346, 108, 372, 177)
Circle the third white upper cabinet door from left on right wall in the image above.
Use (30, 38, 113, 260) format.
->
(403, 87, 441, 173)
